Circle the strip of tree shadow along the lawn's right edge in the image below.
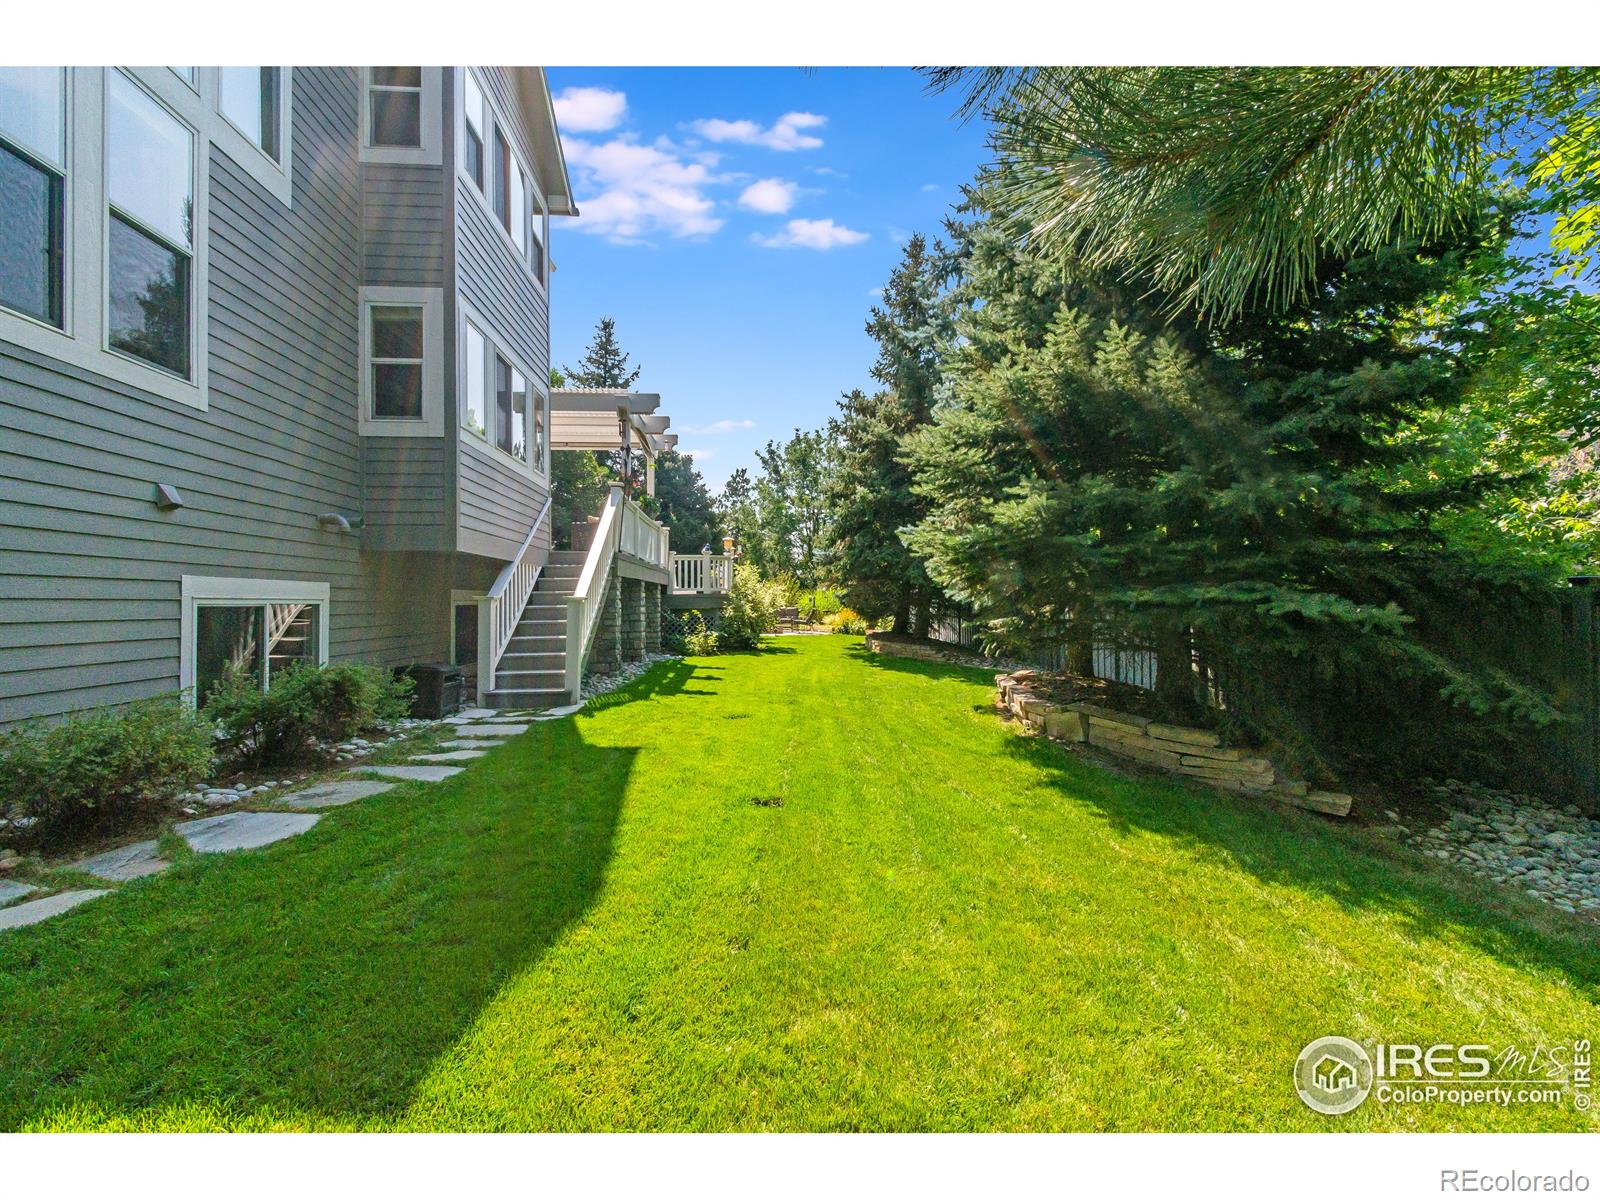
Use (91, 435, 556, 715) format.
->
(846, 646, 1600, 1000)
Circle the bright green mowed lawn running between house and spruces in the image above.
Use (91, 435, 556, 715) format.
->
(0, 637, 1600, 1130)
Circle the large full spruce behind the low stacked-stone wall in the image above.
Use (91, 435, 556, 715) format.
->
(907, 195, 1550, 770)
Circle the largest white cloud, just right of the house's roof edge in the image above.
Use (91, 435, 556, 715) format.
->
(562, 136, 723, 242)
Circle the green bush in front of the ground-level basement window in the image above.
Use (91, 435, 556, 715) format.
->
(205, 662, 413, 766)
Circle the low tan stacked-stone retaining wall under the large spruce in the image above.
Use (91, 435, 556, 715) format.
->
(995, 670, 1352, 816)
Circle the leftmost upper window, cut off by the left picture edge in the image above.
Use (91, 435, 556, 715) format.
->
(0, 67, 67, 328)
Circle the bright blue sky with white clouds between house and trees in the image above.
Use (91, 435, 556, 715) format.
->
(549, 67, 984, 490)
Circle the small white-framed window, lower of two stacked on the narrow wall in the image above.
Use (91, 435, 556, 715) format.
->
(360, 288, 445, 437)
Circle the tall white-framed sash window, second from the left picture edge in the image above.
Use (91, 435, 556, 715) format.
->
(106, 70, 194, 379)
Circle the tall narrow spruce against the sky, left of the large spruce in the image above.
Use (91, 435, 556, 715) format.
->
(827, 234, 944, 635)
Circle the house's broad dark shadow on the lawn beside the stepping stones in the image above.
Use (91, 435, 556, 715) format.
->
(0, 720, 636, 1130)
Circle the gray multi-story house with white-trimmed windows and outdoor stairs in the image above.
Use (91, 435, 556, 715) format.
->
(0, 67, 697, 725)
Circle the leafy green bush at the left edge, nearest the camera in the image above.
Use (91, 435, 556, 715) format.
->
(0, 698, 213, 845)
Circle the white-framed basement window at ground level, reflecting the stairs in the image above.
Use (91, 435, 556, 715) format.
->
(178, 574, 328, 707)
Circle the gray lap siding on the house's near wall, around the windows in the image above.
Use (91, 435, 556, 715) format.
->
(0, 69, 451, 723)
